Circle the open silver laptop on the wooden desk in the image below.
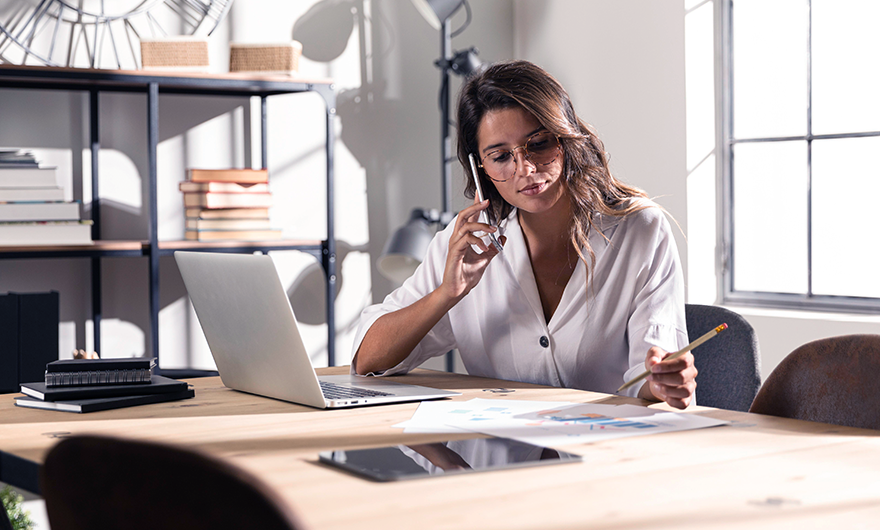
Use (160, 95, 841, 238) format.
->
(174, 251, 461, 409)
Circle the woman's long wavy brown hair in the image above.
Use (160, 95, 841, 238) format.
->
(458, 61, 651, 285)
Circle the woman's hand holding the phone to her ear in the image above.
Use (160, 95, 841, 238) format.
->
(438, 200, 506, 302)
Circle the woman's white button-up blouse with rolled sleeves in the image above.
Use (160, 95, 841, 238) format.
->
(352, 203, 687, 396)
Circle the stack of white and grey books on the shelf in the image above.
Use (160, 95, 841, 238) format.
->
(0, 149, 92, 245)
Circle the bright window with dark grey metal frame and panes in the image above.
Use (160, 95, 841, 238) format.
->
(722, 0, 880, 311)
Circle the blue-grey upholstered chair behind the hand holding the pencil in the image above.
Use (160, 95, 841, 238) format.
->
(684, 304, 761, 412)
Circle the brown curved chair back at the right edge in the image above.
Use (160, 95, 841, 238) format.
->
(749, 335, 880, 429)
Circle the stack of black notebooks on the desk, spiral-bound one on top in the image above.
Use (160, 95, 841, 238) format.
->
(15, 358, 195, 413)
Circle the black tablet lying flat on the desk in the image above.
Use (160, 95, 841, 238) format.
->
(319, 438, 583, 482)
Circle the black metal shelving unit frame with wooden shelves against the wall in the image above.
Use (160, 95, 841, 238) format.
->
(0, 65, 337, 370)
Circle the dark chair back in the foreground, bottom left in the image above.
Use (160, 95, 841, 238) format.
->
(40, 436, 302, 530)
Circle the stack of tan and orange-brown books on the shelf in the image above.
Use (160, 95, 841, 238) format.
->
(180, 169, 281, 241)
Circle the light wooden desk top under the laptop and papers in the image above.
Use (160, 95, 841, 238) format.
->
(0, 368, 880, 530)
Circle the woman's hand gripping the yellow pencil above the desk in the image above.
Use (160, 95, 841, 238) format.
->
(639, 346, 697, 409)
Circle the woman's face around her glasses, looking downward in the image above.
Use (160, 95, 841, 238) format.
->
(477, 107, 566, 214)
